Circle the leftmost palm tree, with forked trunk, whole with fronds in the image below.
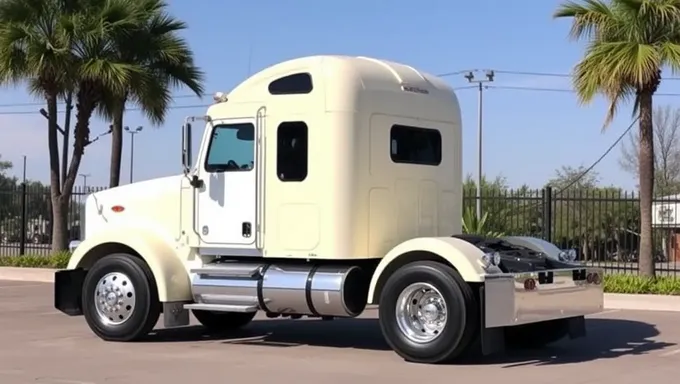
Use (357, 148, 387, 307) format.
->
(0, 0, 147, 251)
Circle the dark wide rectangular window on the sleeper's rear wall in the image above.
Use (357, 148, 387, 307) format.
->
(390, 124, 442, 165)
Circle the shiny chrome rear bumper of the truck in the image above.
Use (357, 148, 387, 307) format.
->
(484, 267, 604, 328)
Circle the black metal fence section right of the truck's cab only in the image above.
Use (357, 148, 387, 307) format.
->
(463, 188, 680, 277)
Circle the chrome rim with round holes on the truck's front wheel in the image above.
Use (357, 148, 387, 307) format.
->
(94, 272, 137, 326)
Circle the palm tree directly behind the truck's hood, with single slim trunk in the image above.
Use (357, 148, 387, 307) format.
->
(99, 0, 204, 187)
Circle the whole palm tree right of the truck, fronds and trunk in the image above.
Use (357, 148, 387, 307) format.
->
(554, 0, 680, 276)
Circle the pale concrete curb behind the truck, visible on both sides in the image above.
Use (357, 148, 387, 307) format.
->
(0, 267, 680, 312)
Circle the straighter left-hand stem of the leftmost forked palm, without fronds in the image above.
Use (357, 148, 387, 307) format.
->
(46, 92, 68, 252)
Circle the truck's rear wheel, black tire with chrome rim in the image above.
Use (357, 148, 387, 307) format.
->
(378, 261, 479, 364)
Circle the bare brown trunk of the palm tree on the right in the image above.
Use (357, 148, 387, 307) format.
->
(638, 91, 654, 276)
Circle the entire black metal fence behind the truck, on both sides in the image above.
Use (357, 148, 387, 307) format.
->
(0, 184, 680, 277)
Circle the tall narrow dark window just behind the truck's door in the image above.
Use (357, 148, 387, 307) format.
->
(276, 121, 309, 182)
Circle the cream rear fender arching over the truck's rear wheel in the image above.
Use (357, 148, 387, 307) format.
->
(368, 237, 486, 303)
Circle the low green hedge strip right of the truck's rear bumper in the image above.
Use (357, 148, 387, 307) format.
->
(604, 274, 680, 295)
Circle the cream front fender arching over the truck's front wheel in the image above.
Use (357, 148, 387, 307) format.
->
(67, 227, 191, 302)
